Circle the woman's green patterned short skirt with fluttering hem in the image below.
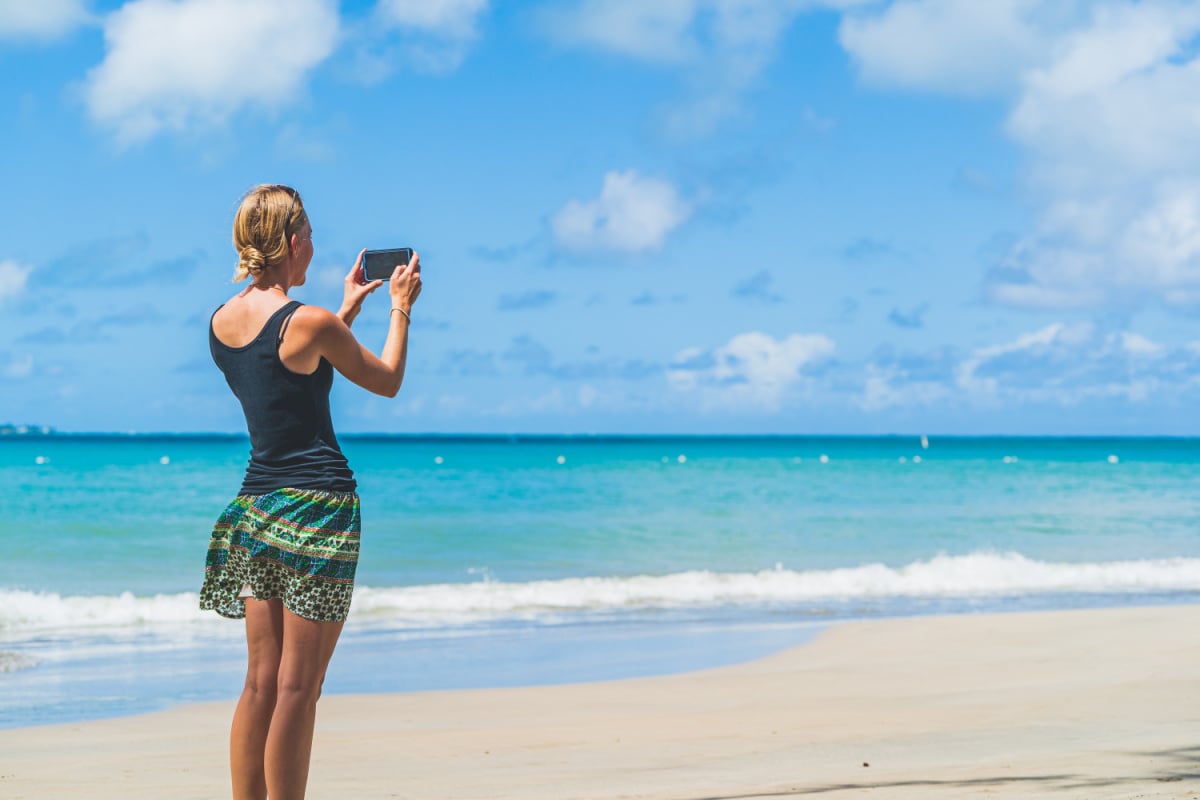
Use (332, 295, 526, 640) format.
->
(200, 489, 361, 622)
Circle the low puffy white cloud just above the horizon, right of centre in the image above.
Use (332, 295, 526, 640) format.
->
(667, 331, 835, 408)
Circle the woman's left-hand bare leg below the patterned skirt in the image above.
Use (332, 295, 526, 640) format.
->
(229, 600, 283, 800)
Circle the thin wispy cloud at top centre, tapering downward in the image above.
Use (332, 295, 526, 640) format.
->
(541, 0, 872, 136)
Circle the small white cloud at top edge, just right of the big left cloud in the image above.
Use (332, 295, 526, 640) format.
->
(376, 0, 488, 73)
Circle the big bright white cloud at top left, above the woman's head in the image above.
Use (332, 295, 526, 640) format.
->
(84, 0, 338, 143)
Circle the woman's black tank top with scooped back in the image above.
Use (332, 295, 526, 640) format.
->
(209, 300, 356, 494)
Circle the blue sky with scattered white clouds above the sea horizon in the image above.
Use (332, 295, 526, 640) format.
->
(0, 0, 1200, 435)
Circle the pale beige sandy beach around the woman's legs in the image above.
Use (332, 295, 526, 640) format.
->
(0, 606, 1200, 800)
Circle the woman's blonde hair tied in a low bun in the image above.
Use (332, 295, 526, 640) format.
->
(233, 184, 308, 283)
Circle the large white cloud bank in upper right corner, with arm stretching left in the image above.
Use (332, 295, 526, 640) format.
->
(841, 0, 1200, 308)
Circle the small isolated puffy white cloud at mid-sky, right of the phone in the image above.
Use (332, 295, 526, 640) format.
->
(551, 170, 691, 252)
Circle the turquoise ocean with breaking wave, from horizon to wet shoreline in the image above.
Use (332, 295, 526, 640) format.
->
(0, 435, 1200, 727)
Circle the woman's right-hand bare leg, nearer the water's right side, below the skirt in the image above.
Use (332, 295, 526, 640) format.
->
(265, 609, 343, 800)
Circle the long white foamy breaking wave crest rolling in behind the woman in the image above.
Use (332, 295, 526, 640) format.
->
(0, 553, 1200, 634)
